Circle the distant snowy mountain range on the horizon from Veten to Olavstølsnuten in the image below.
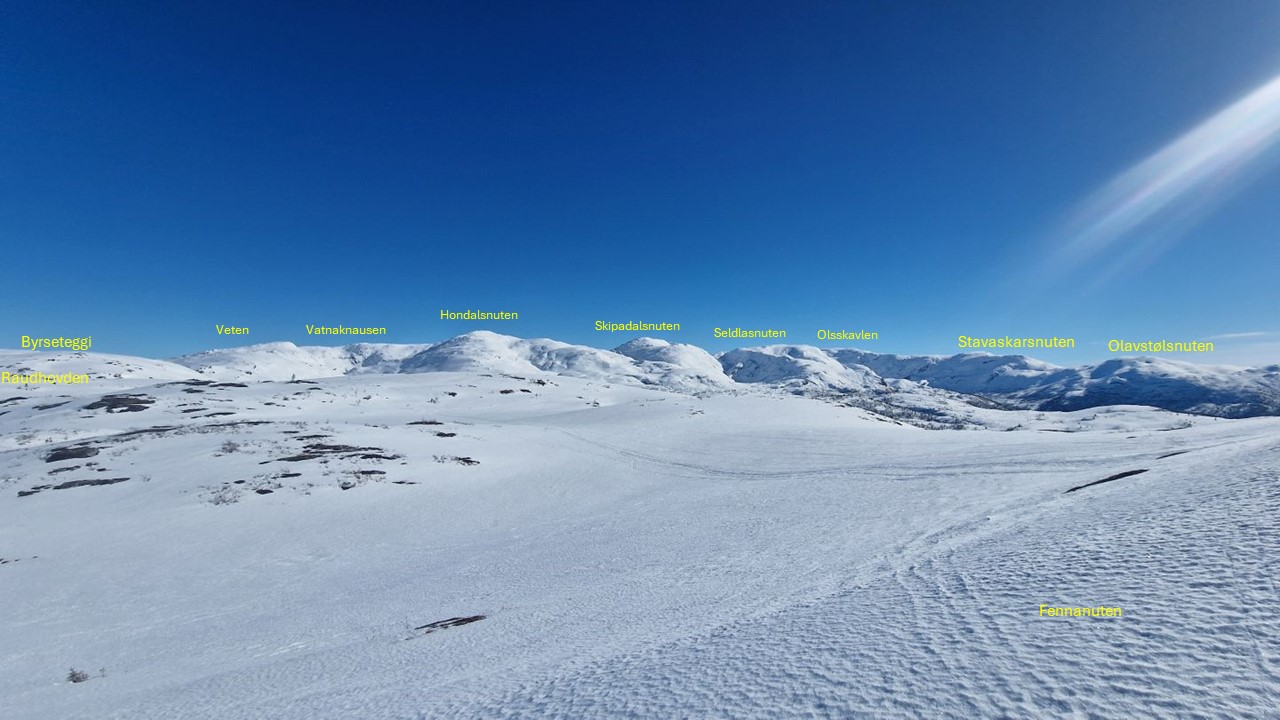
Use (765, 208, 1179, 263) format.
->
(165, 331, 1280, 418)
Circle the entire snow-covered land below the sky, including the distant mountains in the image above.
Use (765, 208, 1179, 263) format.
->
(0, 332, 1280, 720)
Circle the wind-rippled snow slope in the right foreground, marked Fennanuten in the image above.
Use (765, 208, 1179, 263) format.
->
(467, 447, 1280, 717)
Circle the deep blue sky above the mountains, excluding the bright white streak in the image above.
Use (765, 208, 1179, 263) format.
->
(0, 0, 1280, 364)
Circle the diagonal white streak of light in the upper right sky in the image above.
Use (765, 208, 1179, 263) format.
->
(1051, 70, 1280, 278)
